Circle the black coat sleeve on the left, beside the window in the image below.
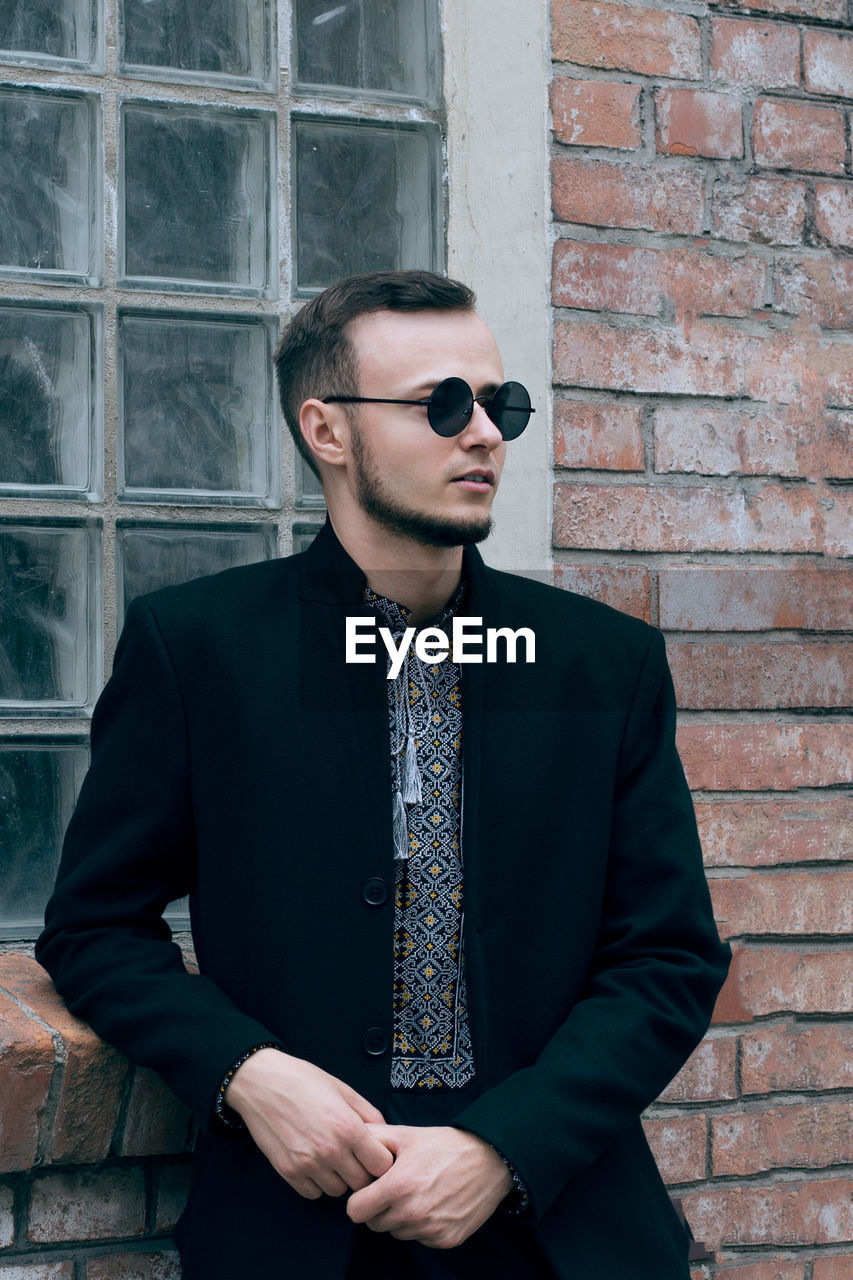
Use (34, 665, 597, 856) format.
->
(36, 600, 281, 1128)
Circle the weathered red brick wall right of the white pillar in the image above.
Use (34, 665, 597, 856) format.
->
(551, 0, 853, 1280)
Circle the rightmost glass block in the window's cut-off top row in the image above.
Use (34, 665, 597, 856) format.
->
(293, 0, 439, 105)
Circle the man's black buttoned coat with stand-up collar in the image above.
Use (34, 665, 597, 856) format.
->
(37, 514, 729, 1280)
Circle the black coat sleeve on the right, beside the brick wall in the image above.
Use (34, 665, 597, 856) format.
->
(455, 631, 730, 1219)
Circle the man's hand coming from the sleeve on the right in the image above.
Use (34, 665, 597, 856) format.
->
(347, 1124, 512, 1249)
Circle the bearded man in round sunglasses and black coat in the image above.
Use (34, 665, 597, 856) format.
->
(37, 264, 727, 1280)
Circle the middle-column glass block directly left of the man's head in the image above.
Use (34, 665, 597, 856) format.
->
(118, 312, 280, 507)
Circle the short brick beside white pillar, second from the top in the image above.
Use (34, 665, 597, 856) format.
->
(551, 77, 643, 151)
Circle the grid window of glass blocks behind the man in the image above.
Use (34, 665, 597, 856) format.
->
(0, 0, 446, 938)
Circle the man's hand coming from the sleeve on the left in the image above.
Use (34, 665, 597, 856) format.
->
(225, 1048, 393, 1199)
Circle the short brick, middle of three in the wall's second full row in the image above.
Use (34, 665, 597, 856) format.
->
(654, 88, 743, 160)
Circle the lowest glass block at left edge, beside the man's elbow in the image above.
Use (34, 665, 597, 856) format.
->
(0, 739, 88, 938)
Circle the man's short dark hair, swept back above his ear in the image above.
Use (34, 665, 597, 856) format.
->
(273, 270, 476, 475)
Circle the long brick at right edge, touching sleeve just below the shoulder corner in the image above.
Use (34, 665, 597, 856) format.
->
(667, 639, 853, 710)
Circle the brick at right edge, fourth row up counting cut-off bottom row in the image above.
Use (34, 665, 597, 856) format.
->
(740, 1021, 853, 1096)
